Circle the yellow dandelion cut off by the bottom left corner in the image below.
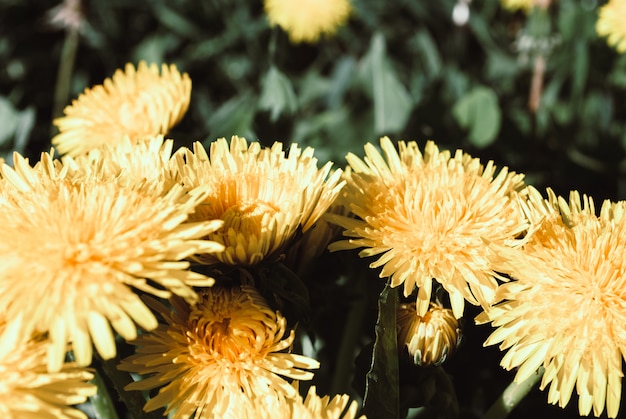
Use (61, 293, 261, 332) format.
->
(0, 323, 96, 419)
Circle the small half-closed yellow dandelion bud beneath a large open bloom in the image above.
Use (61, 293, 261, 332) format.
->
(397, 303, 461, 366)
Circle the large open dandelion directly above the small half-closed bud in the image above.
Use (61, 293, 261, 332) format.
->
(328, 137, 527, 318)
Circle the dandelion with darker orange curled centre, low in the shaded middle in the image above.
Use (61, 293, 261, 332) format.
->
(119, 285, 319, 419)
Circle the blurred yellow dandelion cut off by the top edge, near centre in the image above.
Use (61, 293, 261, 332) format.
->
(265, 0, 351, 43)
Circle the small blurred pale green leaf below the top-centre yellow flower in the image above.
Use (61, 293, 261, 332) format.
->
(259, 66, 298, 122)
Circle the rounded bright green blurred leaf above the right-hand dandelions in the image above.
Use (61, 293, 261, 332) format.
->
(452, 86, 502, 148)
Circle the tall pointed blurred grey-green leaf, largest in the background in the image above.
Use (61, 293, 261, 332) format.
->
(359, 33, 413, 135)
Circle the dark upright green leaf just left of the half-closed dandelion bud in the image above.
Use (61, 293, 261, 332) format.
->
(363, 284, 400, 418)
